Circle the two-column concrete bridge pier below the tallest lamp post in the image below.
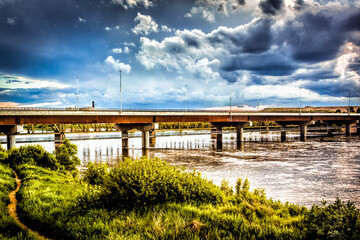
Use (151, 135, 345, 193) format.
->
(115, 123, 154, 149)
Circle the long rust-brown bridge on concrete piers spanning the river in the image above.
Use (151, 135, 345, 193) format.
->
(0, 108, 360, 149)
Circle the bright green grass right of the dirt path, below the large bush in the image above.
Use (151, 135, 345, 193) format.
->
(13, 160, 304, 239)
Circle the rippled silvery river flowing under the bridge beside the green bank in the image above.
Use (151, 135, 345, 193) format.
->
(3, 132, 360, 207)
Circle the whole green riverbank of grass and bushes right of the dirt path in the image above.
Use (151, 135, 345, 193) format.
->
(0, 143, 360, 239)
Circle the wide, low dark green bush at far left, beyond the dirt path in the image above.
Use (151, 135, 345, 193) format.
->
(5, 145, 60, 170)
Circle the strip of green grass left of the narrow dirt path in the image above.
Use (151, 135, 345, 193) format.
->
(0, 163, 36, 239)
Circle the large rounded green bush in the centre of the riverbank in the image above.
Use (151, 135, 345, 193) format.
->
(103, 158, 224, 207)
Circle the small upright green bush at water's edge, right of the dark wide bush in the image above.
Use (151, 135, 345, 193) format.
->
(55, 138, 80, 171)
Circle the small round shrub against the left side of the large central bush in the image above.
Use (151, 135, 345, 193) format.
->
(83, 162, 109, 185)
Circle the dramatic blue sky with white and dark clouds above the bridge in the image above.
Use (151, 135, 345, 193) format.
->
(0, 0, 360, 109)
